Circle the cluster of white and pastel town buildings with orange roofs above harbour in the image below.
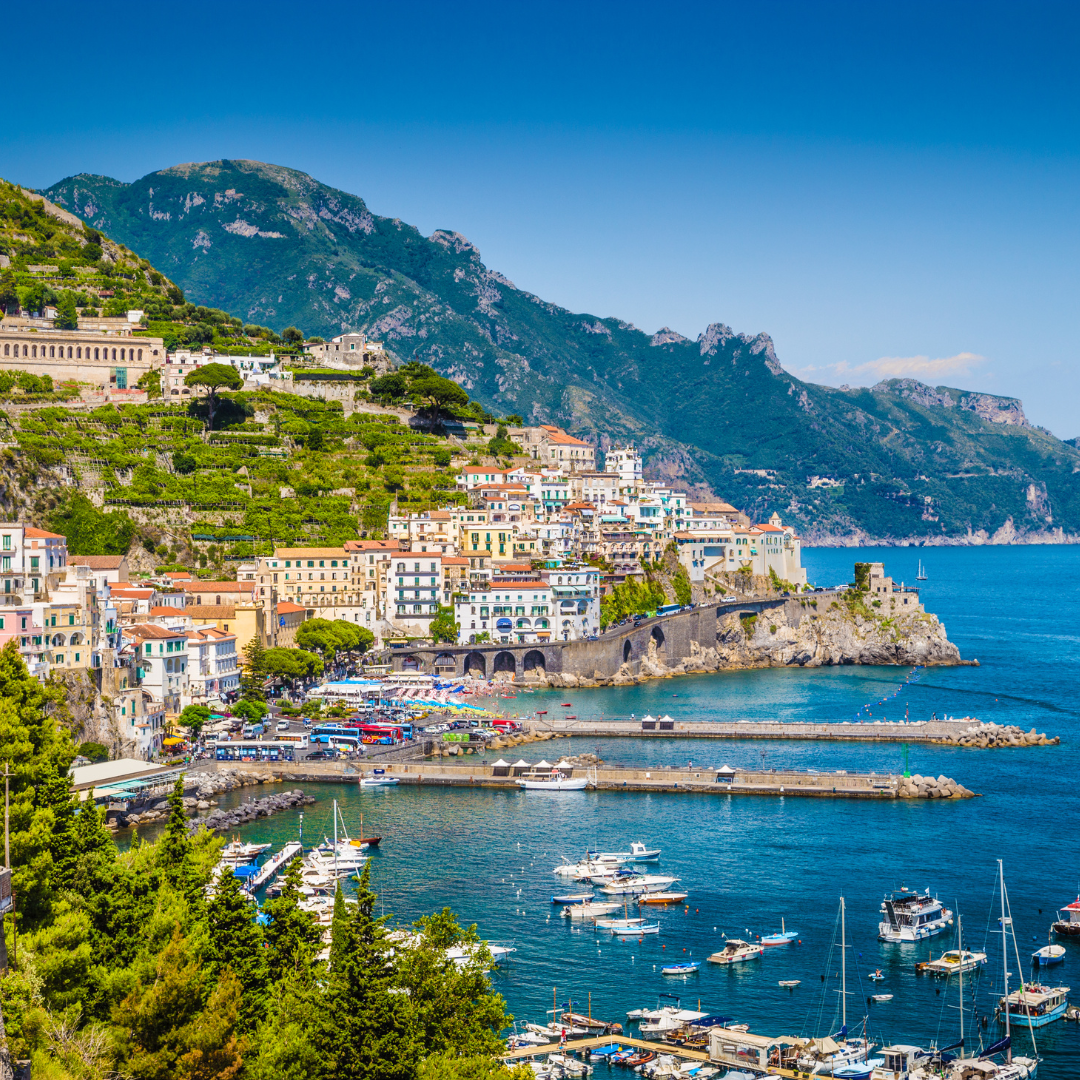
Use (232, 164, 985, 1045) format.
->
(0, 424, 806, 752)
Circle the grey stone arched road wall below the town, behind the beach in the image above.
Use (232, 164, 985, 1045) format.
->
(390, 597, 788, 681)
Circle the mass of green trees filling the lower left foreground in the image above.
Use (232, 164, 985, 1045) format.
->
(0, 647, 524, 1080)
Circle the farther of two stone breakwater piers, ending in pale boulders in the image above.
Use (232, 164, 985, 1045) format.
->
(526, 716, 1059, 750)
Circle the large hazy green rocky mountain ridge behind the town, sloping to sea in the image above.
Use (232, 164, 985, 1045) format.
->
(45, 161, 1080, 543)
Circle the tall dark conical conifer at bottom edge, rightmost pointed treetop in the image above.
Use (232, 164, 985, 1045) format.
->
(326, 863, 420, 1080)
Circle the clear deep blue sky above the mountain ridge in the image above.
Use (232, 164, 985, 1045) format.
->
(8, 0, 1080, 437)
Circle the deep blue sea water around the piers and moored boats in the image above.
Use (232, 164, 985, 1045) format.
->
(166, 546, 1080, 1080)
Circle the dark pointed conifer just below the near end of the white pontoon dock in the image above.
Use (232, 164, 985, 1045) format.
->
(206, 866, 267, 1031)
